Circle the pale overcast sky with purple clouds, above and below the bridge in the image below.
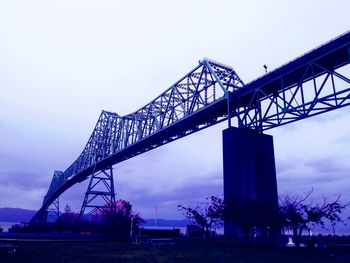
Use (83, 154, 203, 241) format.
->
(0, 0, 350, 232)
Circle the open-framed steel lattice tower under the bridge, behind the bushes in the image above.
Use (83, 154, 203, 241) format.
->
(79, 167, 115, 220)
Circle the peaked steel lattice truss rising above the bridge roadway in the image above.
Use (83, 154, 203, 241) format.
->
(44, 59, 244, 208)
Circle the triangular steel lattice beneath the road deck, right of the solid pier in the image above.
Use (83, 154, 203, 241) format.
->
(233, 60, 350, 131)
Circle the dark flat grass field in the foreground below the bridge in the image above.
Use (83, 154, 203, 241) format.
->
(0, 240, 350, 263)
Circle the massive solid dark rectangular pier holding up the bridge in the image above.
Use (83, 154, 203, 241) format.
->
(223, 127, 278, 237)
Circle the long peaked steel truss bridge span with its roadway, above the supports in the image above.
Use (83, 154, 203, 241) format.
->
(31, 32, 350, 222)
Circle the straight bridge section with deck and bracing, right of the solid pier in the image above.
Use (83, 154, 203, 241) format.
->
(230, 33, 350, 131)
